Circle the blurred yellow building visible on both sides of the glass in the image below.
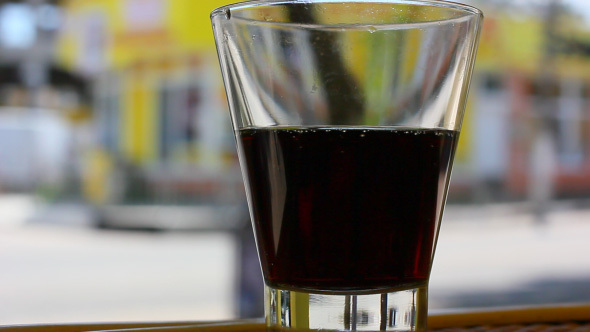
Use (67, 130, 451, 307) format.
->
(49, 0, 590, 211)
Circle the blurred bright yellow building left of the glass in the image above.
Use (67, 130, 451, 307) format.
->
(53, 0, 243, 228)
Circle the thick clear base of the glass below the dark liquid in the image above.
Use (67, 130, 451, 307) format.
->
(264, 284, 428, 331)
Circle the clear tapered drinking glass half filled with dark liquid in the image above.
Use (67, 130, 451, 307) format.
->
(211, 0, 483, 331)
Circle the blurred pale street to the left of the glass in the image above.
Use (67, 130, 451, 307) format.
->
(0, 198, 236, 325)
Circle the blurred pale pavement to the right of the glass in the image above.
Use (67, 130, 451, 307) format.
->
(430, 201, 590, 308)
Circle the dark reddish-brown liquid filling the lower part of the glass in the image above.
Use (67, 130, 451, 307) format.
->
(238, 127, 458, 291)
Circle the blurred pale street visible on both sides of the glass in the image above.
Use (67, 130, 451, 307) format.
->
(0, 197, 590, 324)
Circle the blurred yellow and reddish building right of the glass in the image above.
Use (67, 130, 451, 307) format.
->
(451, 0, 590, 200)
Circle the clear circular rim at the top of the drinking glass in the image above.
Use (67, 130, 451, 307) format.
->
(210, 0, 483, 29)
